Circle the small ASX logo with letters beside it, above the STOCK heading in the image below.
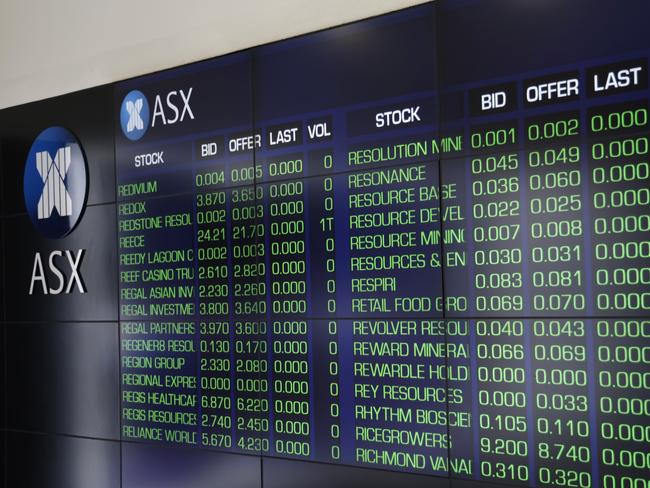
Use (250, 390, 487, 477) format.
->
(120, 87, 194, 141)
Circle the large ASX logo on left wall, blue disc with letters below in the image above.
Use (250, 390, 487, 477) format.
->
(23, 127, 88, 295)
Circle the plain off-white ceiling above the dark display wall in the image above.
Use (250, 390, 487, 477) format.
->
(0, 0, 424, 108)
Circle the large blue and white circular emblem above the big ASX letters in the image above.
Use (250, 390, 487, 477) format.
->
(23, 127, 88, 239)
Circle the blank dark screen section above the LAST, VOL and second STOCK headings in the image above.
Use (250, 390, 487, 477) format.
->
(253, 2, 437, 120)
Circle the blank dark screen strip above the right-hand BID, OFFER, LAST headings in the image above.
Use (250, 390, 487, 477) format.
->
(436, 0, 648, 88)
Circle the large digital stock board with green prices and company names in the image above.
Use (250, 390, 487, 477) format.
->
(115, 1, 650, 488)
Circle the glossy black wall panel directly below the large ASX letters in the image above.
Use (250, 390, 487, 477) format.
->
(5, 323, 120, 440)
